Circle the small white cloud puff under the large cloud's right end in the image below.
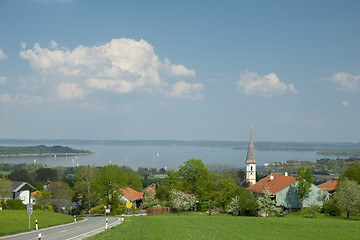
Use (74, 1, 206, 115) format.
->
(167, 81, 204, 100)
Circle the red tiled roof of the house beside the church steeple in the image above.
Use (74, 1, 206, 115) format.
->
(248, 173, 298, 194)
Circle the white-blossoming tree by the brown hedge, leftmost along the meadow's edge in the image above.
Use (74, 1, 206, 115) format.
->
(170, 189, 197, 215)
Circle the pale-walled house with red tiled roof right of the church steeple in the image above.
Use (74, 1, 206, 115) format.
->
(248, 173, 329, 213)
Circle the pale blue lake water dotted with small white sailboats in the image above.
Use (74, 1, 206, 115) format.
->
(0, 140, 338, 170)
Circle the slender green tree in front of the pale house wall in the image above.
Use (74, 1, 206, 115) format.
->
(297, 166, 314, 211)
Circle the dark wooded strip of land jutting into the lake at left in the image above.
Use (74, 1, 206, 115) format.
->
(0, 145, 92, 157)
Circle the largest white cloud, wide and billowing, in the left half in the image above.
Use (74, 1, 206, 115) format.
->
(20, 38, 202, 100)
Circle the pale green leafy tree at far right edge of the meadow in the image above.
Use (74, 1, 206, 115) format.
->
(334, 179, 360, 218)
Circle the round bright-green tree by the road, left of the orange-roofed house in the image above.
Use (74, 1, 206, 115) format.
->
(94, 165, 128, 213)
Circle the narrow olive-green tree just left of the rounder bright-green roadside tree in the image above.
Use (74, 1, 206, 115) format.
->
(75, 166, 98, 211)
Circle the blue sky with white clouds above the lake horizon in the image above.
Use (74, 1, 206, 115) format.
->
(0, 0, 360, 142)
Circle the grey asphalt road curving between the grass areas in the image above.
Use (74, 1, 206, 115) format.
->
(0, 217, 121, 240)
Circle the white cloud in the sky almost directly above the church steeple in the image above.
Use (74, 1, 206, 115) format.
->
(236, 71, 297, 97)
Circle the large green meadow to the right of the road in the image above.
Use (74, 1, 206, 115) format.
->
(89, 213, 360, 240)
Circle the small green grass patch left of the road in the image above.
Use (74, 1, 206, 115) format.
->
(0, 210, 78, 236)
